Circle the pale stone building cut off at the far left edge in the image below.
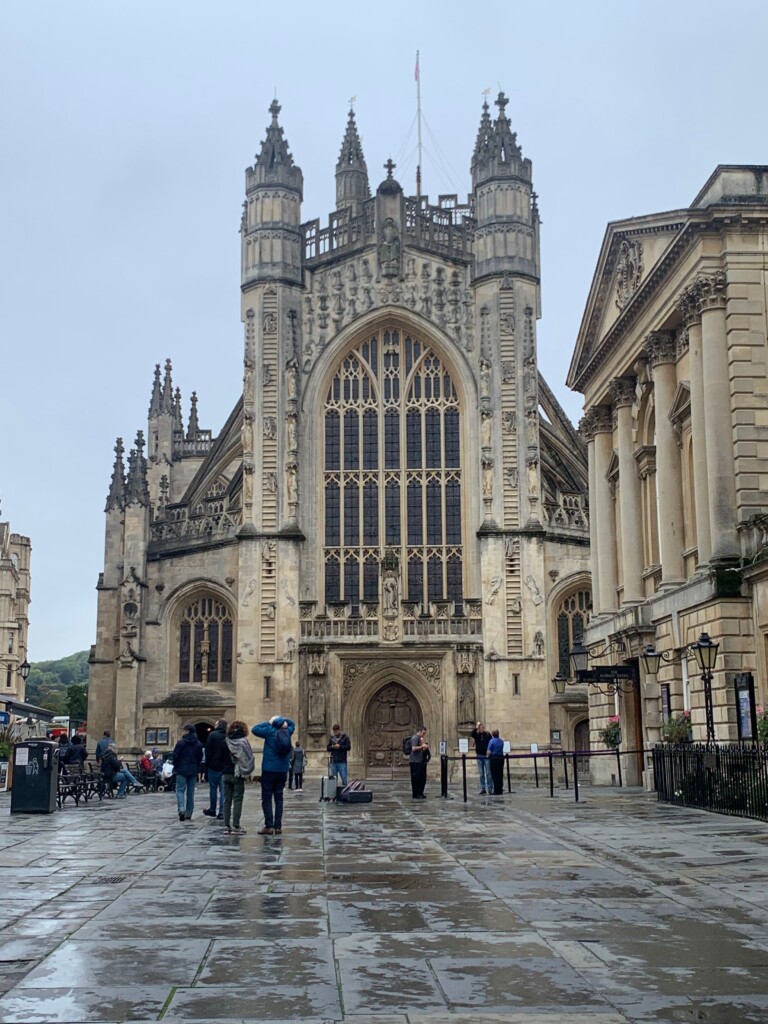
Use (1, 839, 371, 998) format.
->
(0, 522, 32, 702)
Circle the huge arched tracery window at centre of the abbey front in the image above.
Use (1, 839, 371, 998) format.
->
(324, 328, 464, 611)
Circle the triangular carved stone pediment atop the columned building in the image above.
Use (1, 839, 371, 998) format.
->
(567, 211, 688, 391)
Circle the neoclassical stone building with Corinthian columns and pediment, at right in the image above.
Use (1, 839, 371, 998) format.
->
(567, 166, 768, 771)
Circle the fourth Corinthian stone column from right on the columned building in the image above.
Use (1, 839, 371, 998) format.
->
(610, 377, 645, 604)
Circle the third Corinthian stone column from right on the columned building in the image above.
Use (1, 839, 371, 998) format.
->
(645, 331, 685, 587)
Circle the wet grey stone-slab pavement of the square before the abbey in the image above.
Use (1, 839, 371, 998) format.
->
(0, 782, 768, 1024)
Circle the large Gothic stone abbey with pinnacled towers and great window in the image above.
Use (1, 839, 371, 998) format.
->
(88, 94, 591, 769)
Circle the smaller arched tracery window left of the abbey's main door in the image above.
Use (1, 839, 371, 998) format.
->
(178, 594, 233, 686)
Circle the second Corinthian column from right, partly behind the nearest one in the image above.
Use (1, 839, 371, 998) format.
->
(678, 285, 712, 566)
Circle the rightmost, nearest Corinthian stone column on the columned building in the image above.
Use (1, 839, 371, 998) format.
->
(695, 270, 740, 561)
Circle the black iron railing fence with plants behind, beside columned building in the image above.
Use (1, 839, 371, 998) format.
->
(653, 743, 768, 821)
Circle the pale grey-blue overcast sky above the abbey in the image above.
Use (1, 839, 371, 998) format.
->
(0, 0, 768, 660)
